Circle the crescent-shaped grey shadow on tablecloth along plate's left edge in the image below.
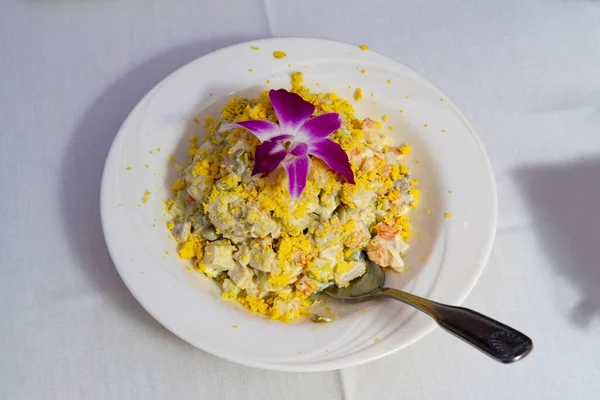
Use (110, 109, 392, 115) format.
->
(60, 38, 262, 337)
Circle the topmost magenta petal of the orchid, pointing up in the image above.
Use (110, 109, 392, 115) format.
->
(269, 89, 315, 135)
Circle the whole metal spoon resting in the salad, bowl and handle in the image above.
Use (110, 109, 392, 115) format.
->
(324, 257, 533, 364)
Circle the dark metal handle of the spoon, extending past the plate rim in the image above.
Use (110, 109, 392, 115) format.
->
(378, 288, 533, 364)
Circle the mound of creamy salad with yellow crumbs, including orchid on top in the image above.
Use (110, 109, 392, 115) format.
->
(166, 73, 419, 322)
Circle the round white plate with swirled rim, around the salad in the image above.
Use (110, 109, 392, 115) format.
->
(101, 38, 497, 371)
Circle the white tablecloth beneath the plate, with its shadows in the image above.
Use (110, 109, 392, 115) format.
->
(0, 0, 600, 400)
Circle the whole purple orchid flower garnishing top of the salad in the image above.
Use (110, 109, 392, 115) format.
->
(219, 89, 354, 199)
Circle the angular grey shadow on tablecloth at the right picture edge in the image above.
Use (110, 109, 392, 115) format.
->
(515, 158, 600, 327)
